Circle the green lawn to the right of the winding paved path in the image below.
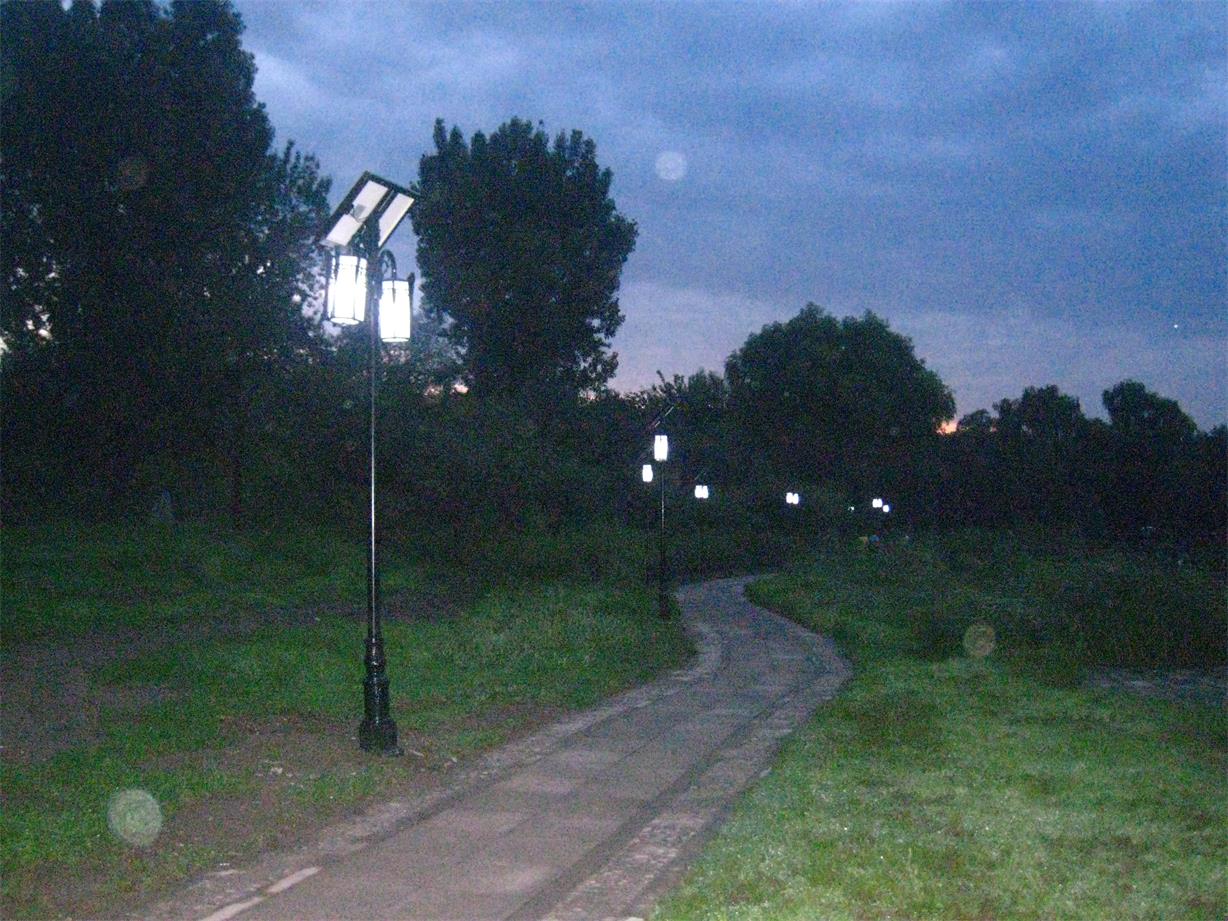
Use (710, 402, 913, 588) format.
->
(653, 535, 1228, 921)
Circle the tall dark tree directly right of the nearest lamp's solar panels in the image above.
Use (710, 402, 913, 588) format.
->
(410, 118, 636, 395)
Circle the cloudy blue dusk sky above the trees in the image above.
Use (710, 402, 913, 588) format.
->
(235, 0, 1228, 429)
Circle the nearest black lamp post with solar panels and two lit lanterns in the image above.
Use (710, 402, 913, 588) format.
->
(322, 173, 414, 755)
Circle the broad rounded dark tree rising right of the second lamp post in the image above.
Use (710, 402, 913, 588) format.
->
(726, 303, 955, 510)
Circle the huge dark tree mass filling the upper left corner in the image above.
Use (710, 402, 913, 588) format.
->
(0, 0, 328, 520)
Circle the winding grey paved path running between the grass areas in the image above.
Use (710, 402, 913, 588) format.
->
(144, 578, 849, 921)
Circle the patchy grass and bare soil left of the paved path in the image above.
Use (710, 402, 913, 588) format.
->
(0, 526, 689, 917)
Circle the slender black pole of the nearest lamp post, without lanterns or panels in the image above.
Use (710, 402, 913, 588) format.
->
(357, 222, 400, 754)
